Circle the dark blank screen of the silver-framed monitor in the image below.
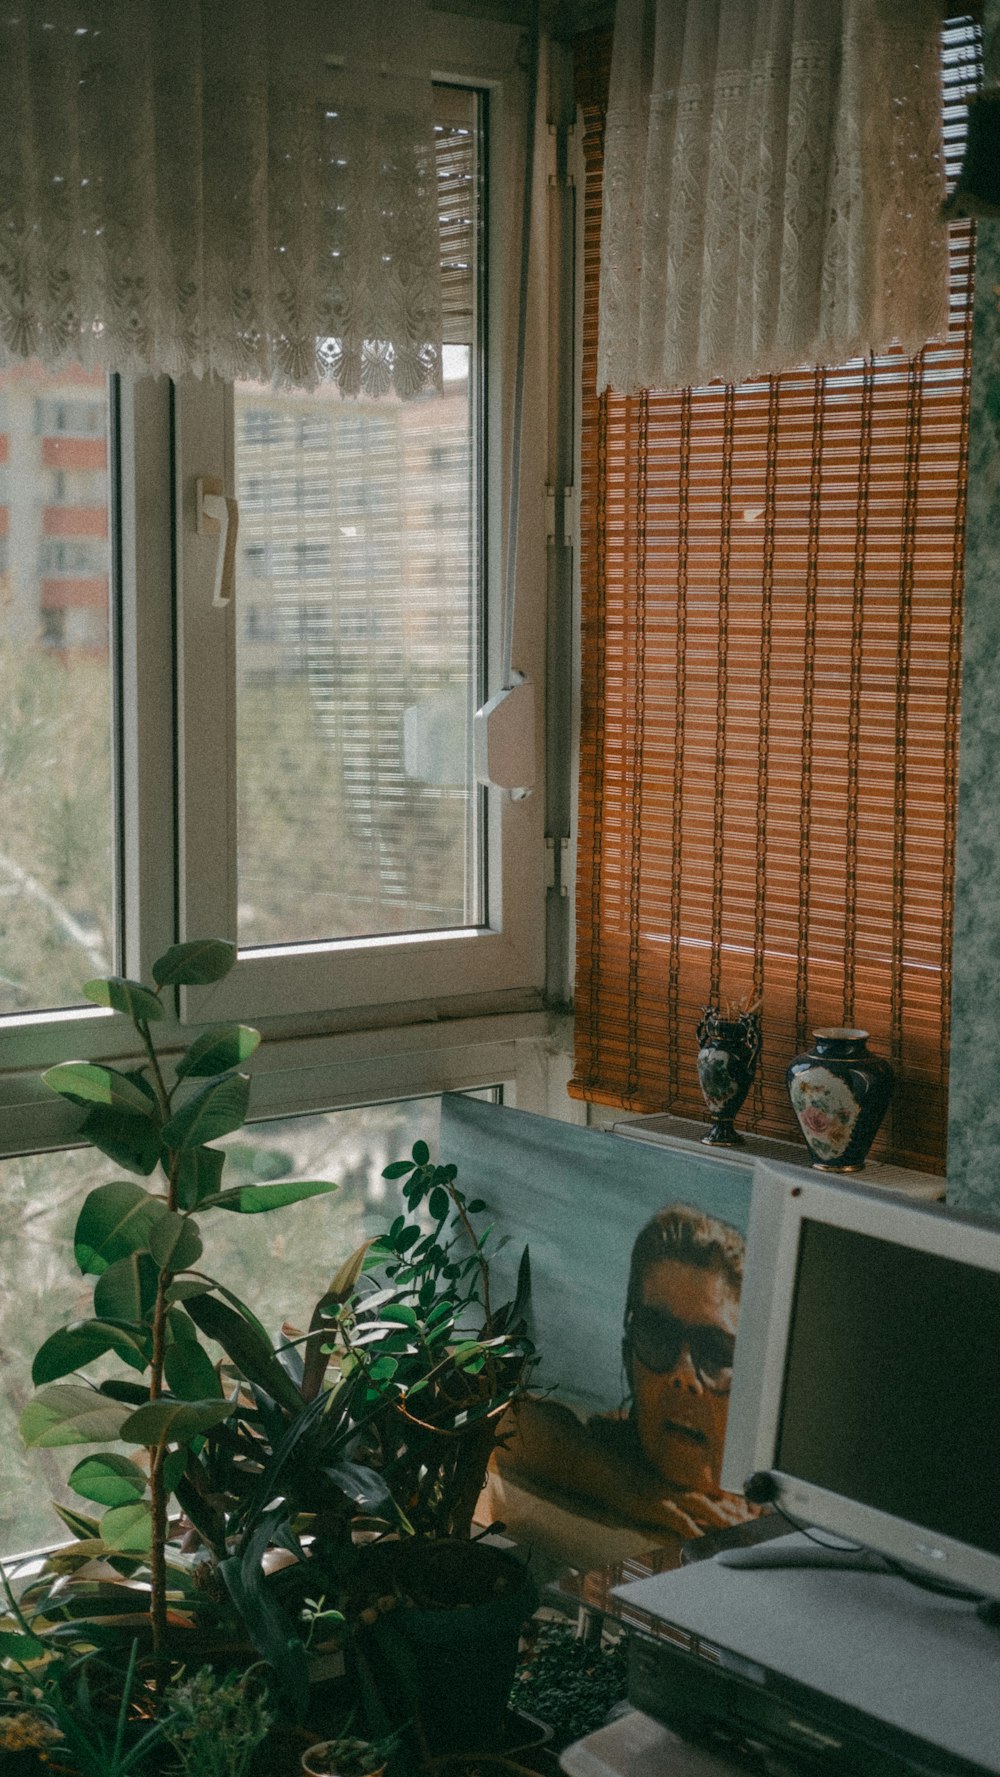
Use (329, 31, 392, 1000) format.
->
(774, 1221, 1000, 1555)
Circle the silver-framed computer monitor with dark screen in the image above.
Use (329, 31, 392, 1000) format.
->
(723, 1162, 1000, 1599)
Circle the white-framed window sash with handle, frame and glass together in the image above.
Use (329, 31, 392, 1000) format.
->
(174, 72, 544, 1016)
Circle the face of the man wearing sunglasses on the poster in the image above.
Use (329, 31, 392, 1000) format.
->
(629, 1258, 739, 1493)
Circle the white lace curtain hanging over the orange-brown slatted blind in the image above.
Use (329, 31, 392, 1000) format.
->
(597, 0, 948, 393)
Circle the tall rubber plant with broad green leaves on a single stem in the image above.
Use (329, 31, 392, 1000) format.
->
(21, 938, 336, 1670)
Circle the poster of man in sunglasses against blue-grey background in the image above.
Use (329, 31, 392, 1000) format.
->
(442, 1100, 753, 1567)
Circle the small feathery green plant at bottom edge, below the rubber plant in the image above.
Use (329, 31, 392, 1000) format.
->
(165, 1667, 275, 1777)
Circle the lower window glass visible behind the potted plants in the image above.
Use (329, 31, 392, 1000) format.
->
(0, 1096, 449, 1553)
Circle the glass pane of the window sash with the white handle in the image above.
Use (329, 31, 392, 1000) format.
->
(236, 89, 483, 947)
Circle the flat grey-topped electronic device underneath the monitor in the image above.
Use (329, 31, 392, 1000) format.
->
(615, 1535, 1000, 1777)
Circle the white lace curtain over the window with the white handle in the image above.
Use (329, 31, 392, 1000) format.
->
(0, 0, 442, 396)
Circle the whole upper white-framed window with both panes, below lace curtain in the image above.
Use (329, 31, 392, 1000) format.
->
(0, 16, 547, 1155)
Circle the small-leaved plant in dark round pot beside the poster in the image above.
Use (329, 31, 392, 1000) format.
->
(323, 1143, 538, 1754)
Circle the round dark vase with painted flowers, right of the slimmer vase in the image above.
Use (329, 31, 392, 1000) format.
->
(787, 1027, 895, 1173)
